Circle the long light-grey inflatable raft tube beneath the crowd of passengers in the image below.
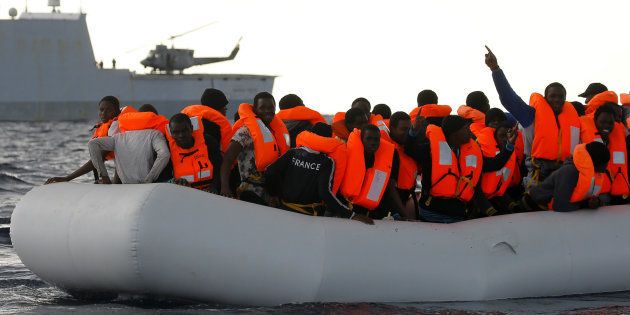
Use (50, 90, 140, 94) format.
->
(11, 183, 630, 305)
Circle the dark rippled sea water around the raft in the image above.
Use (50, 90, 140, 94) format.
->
(0, 122, 630, 314)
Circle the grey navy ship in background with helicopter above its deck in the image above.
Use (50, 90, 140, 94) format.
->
(0, 0, 275, 121)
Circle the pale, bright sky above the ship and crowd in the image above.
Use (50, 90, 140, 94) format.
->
(0, 0, 630, 113)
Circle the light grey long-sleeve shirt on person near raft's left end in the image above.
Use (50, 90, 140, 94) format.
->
(88, 129, 171, 184)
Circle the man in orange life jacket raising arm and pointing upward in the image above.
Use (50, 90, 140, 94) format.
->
(485, 47, 580, 188)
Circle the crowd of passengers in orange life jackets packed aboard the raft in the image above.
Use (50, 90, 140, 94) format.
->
(46, 49, 630, 224)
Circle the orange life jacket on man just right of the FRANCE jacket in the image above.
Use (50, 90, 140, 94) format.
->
(341, 129, 395, 210)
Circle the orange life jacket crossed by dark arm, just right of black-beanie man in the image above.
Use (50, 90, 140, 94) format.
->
(477, 127, 517, 198)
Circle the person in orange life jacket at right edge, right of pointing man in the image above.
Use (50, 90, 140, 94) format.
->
(580, 103, 630, 204)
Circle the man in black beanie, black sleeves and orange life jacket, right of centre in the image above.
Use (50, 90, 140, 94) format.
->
(405, 115, 484, 223)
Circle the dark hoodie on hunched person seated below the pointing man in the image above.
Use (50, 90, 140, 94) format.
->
(529, 157, 581, 212)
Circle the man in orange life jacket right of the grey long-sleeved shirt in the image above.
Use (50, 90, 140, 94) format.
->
(166, 114, 222, 193)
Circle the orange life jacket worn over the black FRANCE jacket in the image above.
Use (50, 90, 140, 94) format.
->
(295, 131, 348, 194)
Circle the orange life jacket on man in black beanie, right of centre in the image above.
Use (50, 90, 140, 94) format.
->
(426, 125, 483, 202)
